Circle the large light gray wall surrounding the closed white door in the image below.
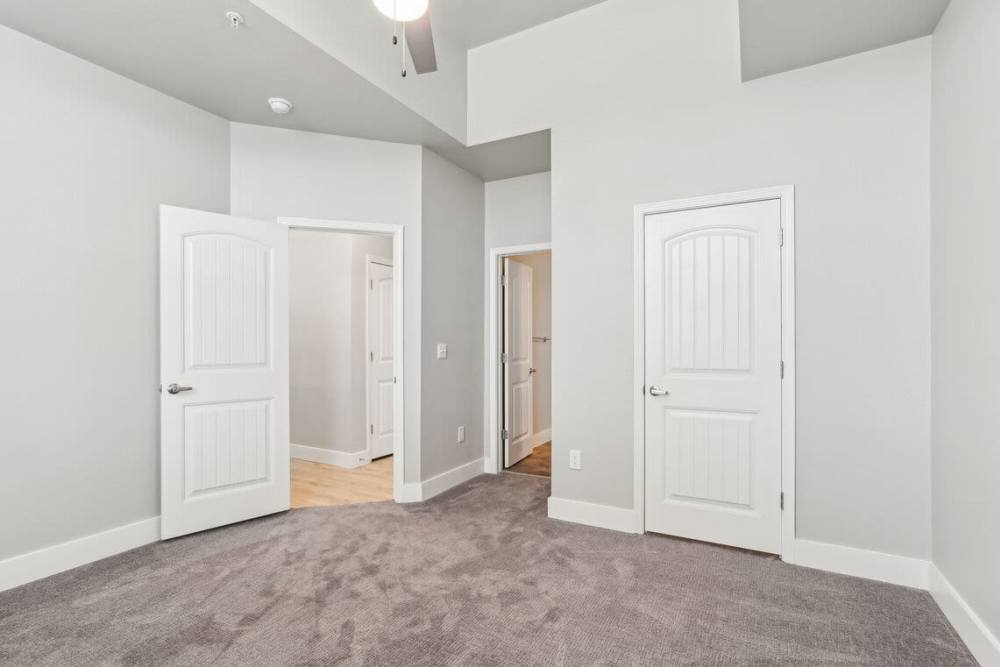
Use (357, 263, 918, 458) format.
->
(469, 0, 930, 557)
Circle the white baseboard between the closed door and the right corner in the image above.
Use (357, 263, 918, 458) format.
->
(782, 540, 930, 590)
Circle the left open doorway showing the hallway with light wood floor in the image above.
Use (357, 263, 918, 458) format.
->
(288, 228, 395, 508)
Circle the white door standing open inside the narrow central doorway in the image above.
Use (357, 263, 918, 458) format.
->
(502, 258, 534, 467)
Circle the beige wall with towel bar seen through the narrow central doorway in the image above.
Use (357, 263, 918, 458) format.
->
(512, 252, 554, 434)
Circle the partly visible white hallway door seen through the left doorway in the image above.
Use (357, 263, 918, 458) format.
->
(368, 261, 396, 459)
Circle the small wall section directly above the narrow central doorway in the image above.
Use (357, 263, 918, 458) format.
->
(486, 171, 552, 249)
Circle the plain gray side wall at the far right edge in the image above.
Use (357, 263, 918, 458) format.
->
(931, 0, 1000, 635)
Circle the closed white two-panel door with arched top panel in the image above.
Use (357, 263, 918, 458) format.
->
(645, 199, 781, 553)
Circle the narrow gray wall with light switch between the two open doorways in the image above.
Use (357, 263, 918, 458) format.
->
(421, 149, 485, 479)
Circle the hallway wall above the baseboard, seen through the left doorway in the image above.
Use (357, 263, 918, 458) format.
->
(288, 229, 392, 452)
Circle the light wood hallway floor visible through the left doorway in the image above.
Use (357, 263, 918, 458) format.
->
(292, 456, 392, 507)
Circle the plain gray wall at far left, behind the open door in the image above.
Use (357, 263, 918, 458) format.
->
(0, 27, 229, 558)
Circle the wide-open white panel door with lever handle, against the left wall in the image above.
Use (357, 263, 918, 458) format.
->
(160, 206, 289, 539)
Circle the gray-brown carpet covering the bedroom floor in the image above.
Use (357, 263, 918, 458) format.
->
(0, 475, 975, 665)
